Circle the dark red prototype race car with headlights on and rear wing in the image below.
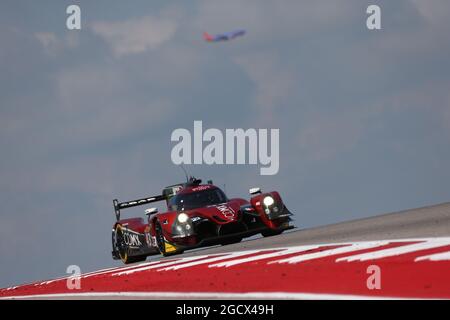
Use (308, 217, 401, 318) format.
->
(112, 177, 294, 264)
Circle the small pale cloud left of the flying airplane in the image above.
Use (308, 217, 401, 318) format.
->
(92, 16, 177, 57)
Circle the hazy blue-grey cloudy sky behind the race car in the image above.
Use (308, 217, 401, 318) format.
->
(0, 0, 450, 287)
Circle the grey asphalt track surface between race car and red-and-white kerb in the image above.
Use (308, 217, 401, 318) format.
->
(147, 202, 450, 261)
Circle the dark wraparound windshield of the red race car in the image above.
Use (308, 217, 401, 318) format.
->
(168, 189, 227, 211)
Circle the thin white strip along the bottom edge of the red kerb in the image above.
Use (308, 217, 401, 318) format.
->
(0, 292, 421, 300)
